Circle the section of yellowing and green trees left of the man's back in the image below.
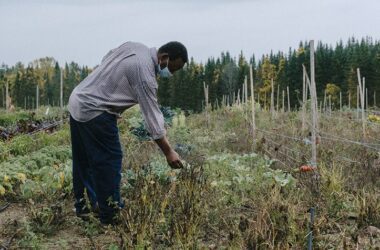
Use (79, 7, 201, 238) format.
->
(0, 57, 91, 109)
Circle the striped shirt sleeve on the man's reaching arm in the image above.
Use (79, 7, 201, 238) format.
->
(135, 81, 166, 140)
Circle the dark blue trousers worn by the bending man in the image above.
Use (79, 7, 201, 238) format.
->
(70, 112, 123, 223)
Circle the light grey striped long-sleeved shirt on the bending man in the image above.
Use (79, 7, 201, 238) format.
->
(68, 42, 166, 139)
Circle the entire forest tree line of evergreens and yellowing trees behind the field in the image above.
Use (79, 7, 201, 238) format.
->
(0, 37, 380, 112)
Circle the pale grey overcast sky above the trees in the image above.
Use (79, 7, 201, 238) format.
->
(0, 0, 380, 67)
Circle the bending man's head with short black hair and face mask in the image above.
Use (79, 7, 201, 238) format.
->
(157, 42, 188, 74)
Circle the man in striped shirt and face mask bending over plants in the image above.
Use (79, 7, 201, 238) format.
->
(68, 42, 188, 224)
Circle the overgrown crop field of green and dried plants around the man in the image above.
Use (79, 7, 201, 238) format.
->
(0, 103, 380, 249)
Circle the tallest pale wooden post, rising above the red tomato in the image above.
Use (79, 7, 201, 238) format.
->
(310, 40, 318, 167)
